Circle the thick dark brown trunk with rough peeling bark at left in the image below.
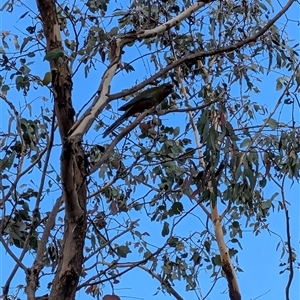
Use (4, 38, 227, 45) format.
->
(26, 0, 87, 300)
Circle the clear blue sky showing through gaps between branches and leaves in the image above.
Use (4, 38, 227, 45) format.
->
(0, 1, 300, 300)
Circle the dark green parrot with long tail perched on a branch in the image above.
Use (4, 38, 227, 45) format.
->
(103, 83, 173, 138)
